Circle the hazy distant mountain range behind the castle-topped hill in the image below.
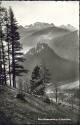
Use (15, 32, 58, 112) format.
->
(19, 22, 79, 61)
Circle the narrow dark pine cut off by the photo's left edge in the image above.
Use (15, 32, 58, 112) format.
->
(0, 4, 7, 84)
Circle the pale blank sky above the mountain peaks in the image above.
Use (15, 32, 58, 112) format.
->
(3, 1, 79, 29)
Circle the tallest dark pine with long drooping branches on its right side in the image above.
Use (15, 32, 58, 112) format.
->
(9, 8, 27, 87)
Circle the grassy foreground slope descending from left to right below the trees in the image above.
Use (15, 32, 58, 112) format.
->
(0, 87, 77, 124)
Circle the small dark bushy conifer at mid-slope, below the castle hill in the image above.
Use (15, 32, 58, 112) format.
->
(30, 65, 45, 95)
